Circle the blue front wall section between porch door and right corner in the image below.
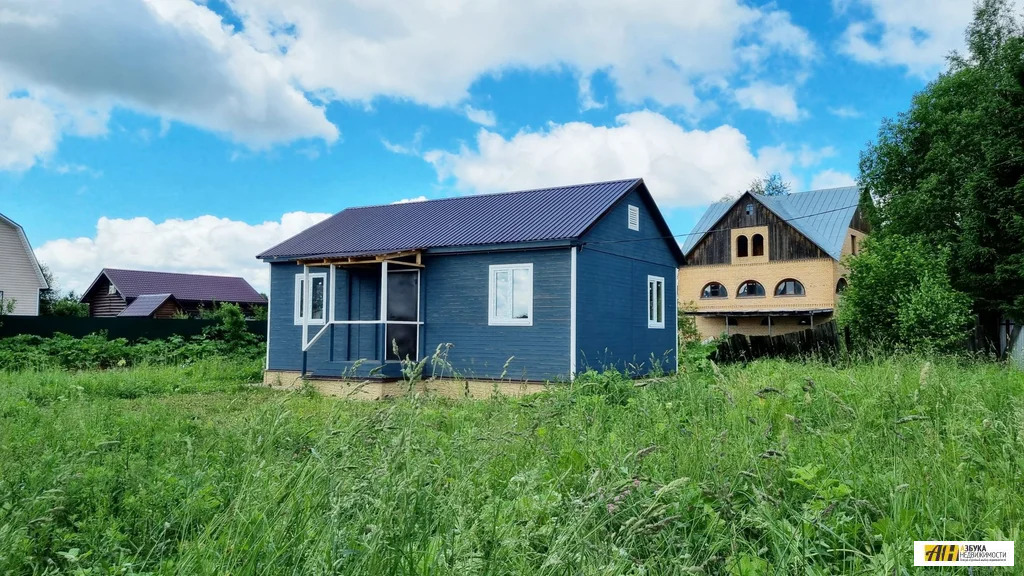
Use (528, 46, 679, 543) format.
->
(421, 247, 570, 380)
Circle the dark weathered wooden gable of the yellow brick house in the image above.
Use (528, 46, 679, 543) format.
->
(686, 193, 829, 265)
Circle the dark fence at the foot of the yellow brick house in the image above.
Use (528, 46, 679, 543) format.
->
(712, 320, 840, 363)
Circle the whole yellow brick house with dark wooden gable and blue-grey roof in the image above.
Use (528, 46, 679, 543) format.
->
(679, 187, 870, 337)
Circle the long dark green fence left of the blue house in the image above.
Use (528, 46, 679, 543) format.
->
(0, 316, 266, 340)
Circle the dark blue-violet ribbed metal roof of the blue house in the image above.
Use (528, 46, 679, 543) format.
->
(257, 178, 651, 259)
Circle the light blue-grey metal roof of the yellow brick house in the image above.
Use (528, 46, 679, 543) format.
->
(683, 187, 860, 260)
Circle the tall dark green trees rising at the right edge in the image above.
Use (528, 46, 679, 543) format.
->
(851, 0, 1024, 318)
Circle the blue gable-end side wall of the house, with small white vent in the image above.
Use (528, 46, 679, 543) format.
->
(577, 192, 677, 373)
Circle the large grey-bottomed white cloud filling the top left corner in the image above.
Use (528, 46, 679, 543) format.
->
(0, 0, 338, 169)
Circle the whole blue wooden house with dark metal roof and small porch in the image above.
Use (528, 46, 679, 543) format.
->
(258, 179, 683, 381)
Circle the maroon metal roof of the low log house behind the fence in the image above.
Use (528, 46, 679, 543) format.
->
(82, 268, 266, 305)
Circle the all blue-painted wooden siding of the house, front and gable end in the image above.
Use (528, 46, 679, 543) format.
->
(268, 186, 676, 380)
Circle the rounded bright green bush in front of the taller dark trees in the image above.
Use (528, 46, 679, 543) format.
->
(839, 236, 971, 352)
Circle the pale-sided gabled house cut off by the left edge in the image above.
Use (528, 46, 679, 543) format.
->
(0, 214, 49, 316)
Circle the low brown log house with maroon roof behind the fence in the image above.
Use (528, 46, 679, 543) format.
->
(82, 269, 267, 318)
